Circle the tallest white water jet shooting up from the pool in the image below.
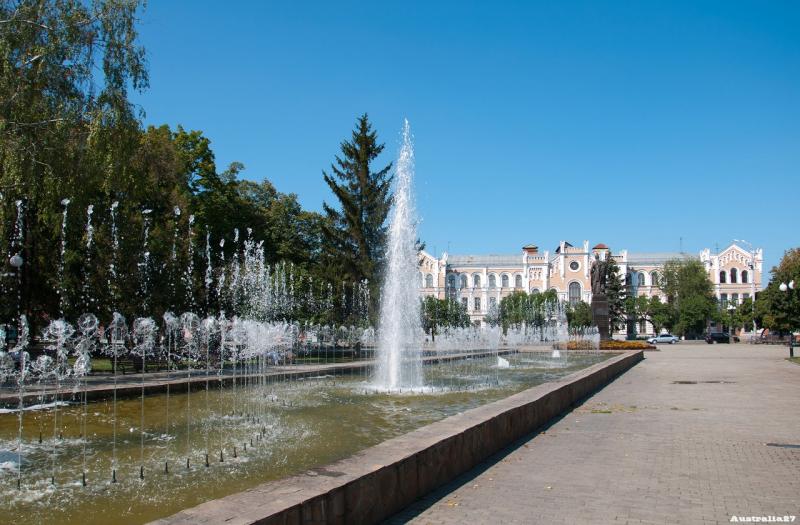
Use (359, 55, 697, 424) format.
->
(375, 120, 423, 390)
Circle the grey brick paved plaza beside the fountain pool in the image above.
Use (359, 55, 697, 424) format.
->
(389, 343, 800, 524)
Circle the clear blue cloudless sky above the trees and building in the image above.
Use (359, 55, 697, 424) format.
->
(128, 0, 800, 274)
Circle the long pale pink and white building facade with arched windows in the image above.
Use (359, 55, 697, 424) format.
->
(420, 241, 763, 334)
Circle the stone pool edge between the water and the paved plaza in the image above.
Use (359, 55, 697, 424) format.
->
(152, 350, 644, 525)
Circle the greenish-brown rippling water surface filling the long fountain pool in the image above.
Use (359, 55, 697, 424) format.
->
(0, 354, 606, 524)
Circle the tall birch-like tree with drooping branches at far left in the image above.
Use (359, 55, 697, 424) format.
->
(0, 0, 148, 330)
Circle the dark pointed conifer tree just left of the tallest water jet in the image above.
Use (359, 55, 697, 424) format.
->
(322, 113, 392, 317)
